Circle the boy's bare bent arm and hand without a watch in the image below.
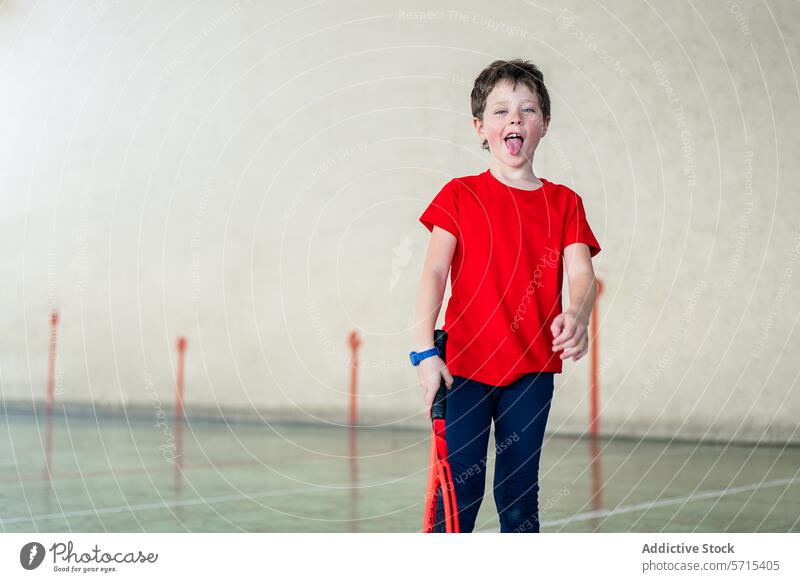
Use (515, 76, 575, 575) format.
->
(551, 243, 597, 360)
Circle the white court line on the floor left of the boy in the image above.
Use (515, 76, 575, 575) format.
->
(0, 481, 395, 524)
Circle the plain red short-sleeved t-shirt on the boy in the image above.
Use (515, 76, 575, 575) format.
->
(419, 170, 600, 386)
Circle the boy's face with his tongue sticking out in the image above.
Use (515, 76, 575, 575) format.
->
(473, 81, 550, 167)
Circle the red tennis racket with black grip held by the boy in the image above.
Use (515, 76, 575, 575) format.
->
(422, 329, 461, 533)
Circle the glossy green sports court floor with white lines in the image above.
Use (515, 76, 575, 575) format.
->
(0, 411, 800, 532)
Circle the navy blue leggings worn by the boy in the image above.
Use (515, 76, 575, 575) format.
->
(446, 372, 553, 533)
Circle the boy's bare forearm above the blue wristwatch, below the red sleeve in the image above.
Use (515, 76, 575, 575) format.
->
(413, 226, 457, 352)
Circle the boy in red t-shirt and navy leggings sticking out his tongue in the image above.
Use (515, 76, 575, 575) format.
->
(413, 59, 600, 532)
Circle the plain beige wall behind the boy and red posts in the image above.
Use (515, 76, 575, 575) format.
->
(0, 0, 800, 442)
